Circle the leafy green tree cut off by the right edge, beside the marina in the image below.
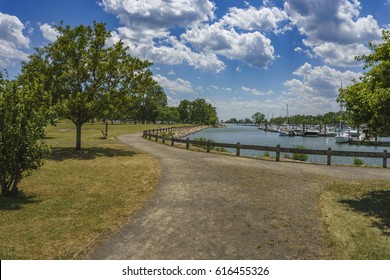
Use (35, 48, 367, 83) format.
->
(337, 30, 390, 136)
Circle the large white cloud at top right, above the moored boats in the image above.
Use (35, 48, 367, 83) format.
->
(285, 0, 381, 66)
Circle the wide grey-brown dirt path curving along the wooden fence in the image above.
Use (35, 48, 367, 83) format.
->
(89, 134, 390, 260)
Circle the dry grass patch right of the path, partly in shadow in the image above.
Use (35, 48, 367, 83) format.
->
(320, 181, 390, 260)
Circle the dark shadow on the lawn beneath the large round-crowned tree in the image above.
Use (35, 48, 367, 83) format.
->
(48, 147, 136, 161)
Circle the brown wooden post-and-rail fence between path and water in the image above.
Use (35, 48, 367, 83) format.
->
(143, 127, 388, 168)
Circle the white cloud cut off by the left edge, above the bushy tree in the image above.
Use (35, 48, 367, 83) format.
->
(0, 12, 30, 66)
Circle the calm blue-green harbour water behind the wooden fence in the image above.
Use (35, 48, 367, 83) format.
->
(189, 125, 390, 166)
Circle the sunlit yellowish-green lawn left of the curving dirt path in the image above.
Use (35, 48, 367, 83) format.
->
(0, 121, 178, 259)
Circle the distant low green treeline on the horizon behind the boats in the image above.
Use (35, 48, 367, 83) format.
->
(225, 112, 341, 126)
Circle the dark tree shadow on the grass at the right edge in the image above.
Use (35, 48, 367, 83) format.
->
(340, 191, 390, 236)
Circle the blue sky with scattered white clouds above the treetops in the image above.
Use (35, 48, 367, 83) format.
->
(0, 0, 390, 120)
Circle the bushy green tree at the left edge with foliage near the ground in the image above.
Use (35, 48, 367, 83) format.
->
(0, 75, 49, 196)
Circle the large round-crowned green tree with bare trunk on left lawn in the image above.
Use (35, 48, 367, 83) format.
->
(22, 22, 156, 150)
